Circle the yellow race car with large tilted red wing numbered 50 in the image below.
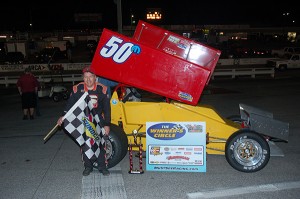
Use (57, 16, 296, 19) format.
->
(91, 21, 289, 173)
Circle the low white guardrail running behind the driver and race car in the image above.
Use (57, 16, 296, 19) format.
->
(0, 68, 275, 87)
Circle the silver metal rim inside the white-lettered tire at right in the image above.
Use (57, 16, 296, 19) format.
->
(234, 139, 263, 166)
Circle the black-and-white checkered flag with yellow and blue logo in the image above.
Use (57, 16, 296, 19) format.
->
(63, 92, 105, 160)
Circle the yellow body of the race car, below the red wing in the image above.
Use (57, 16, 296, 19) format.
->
(111, 92, 241, 155)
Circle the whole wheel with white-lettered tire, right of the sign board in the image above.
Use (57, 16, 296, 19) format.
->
(225, 129, 270, 173)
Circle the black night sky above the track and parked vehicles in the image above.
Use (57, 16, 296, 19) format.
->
(0, 0, 300, 31)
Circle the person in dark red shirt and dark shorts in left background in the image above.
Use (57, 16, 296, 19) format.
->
(17, 67, 38, 120)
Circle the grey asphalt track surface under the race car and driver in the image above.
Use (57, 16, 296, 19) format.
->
(0, 73, 300, 199)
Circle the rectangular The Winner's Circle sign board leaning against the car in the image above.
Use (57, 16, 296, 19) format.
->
(146, 122, 206, 172)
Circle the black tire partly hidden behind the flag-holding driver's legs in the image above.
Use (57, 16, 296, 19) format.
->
(106, 124, 128, 168)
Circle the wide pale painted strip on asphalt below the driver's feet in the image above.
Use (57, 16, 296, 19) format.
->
(81, 165, 127, 199)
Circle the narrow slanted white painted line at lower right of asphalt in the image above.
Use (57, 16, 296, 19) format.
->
(187, 181, 300, 199)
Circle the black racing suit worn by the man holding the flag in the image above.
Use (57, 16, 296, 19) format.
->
(64, 82, 111, 170)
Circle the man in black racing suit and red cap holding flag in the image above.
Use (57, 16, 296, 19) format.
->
(57, 67, 111, 176)
